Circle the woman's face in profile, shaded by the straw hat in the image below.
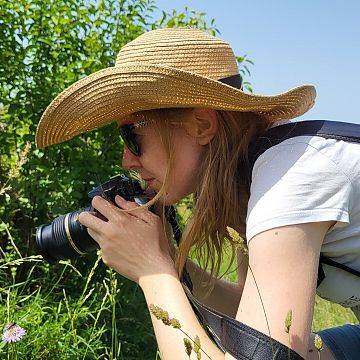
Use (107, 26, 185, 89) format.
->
(122, 107, 217, 205)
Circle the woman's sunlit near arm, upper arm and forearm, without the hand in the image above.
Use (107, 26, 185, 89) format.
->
(139, 222, 333, 360)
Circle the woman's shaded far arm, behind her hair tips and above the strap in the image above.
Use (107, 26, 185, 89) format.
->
(186, 251, 248, 318)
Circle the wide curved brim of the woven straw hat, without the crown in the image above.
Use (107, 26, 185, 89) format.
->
(36, 64, 316, 148)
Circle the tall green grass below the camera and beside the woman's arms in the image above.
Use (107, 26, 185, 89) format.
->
(0, 202, 357, 360)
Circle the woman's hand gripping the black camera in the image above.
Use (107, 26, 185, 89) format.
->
(78, 196, 176, 283)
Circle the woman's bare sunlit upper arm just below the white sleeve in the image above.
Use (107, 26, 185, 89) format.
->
(225, 221, 334, 359)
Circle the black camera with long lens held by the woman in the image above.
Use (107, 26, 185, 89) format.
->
(36, 175, 160, 263)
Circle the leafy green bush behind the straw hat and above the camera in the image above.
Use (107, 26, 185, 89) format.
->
(0, 0, 253, 255)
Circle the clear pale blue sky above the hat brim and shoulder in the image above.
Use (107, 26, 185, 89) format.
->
(153, 0, 360, 124)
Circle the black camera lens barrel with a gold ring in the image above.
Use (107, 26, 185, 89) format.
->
(36, 208, 99, 263)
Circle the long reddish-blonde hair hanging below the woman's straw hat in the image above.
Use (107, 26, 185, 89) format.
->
(121, 108, 275, 286)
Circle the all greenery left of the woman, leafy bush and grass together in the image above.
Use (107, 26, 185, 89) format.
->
(0, 0, 253, 359)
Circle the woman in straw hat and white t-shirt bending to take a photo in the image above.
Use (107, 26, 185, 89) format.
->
(36, 28, 360, 359)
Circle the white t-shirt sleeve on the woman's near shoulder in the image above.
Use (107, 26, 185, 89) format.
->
(246, 139, 352, 242)
